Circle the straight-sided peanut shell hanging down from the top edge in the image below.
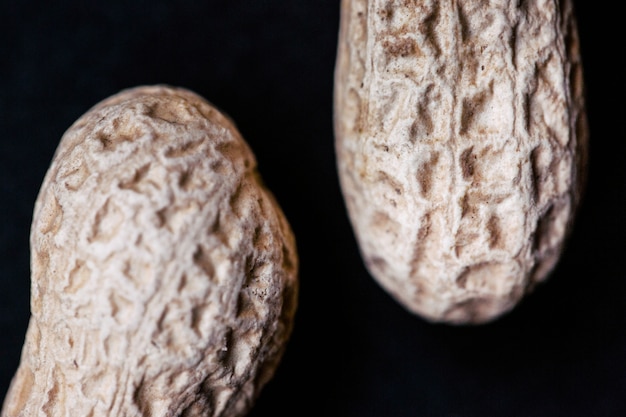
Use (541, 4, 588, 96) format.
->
(335, 0, 588, 324)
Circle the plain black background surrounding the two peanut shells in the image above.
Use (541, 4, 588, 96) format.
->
(0, 0, 626, 417)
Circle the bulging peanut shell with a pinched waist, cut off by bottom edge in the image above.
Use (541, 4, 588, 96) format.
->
(2, 86, 298, 417)
